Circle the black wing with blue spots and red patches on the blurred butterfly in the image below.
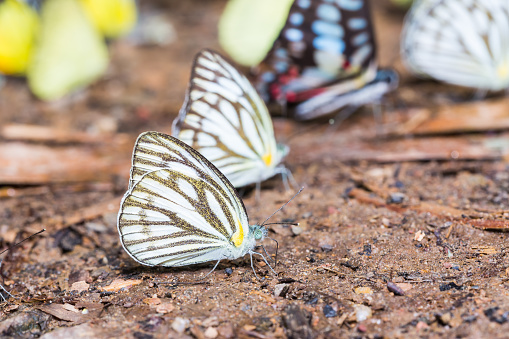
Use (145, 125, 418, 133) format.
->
(255, 0, 377, 103)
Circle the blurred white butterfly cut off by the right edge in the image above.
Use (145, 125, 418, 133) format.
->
(401, 0, 509, 91)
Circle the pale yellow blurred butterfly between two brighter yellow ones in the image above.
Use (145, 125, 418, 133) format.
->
(27, 0, 109, 100)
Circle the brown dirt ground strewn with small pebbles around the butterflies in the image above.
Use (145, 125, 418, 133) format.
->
(0, 0, 509, 338)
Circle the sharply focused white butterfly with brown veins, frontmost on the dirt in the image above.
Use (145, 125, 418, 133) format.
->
(118, 132, 298, 274)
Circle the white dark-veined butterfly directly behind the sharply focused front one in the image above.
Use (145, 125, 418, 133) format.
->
(172, 49, 294, 188)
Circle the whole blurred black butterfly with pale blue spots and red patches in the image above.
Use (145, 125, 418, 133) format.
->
(249, 0, 398, 120)
